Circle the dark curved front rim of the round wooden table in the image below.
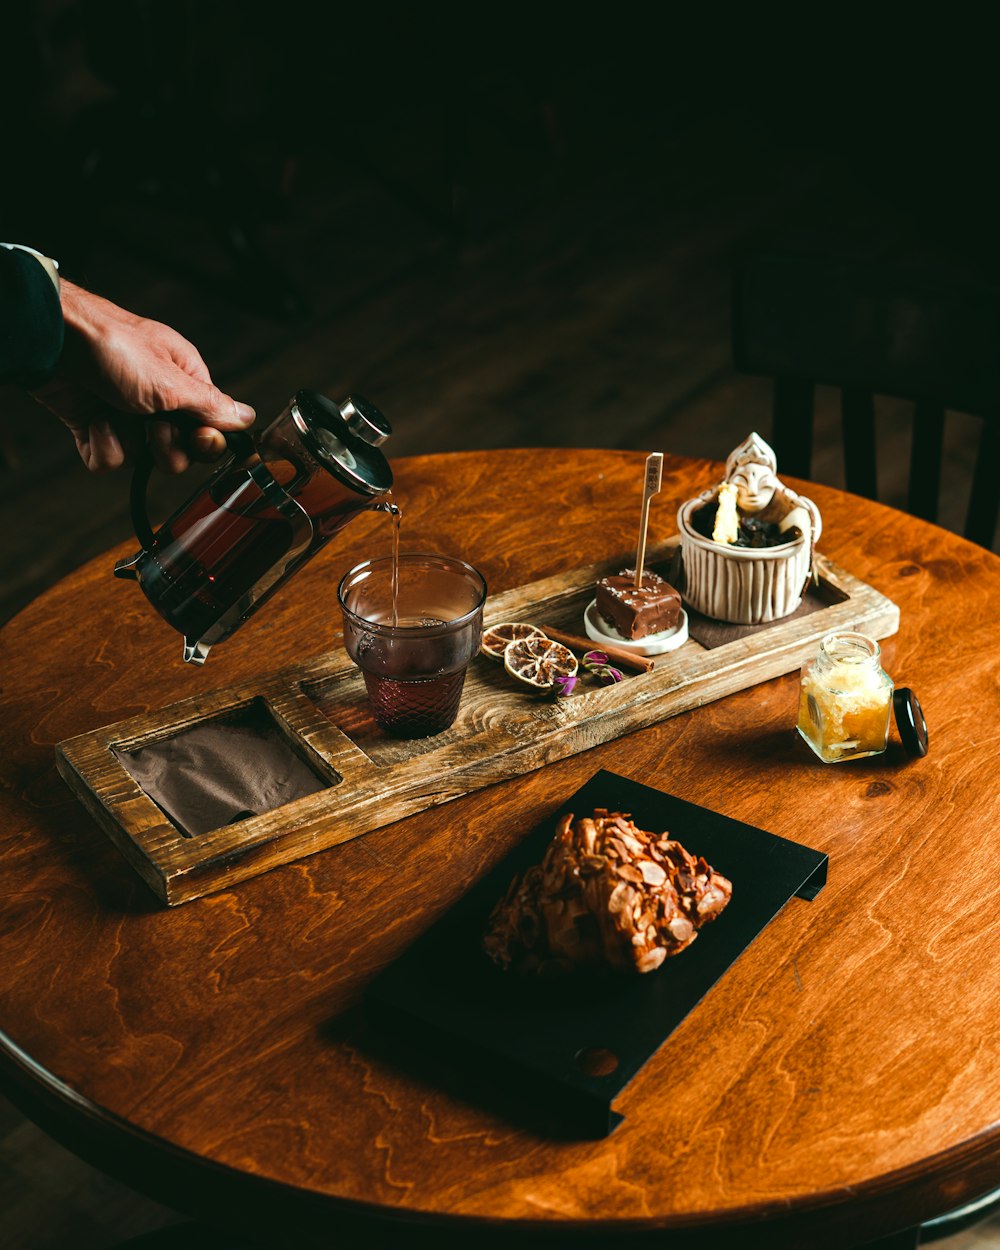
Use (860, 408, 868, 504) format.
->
(0, 1030, 1000, 1250)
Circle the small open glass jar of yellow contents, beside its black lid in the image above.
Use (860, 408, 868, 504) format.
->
(798, 634, 893, 764)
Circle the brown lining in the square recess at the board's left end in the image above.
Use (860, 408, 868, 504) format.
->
(115, 706, 329, 838)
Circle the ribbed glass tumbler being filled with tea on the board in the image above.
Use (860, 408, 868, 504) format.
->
(338, 551, 486, 738)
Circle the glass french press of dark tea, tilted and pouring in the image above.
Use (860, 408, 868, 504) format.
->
(115, 390, 394, 664)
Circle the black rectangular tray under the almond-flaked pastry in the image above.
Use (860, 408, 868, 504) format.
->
(365, 770, 826, 1138)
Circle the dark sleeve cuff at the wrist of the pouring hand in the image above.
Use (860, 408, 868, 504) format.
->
(0, 248, 63, 386)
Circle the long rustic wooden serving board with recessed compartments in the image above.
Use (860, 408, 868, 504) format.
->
(56, 544, 899, 905)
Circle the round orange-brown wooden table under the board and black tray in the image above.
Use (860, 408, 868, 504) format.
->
(0, 451, 1000, 1246)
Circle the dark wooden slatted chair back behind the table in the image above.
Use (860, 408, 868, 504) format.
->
(733, 245, 1000, 548)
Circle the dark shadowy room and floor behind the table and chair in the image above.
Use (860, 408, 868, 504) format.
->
(0, 0, 998, 616)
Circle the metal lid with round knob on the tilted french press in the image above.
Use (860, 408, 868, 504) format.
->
(289, 390, 393, 495)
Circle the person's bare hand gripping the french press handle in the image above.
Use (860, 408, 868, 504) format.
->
(34, 280, 254, 473)
